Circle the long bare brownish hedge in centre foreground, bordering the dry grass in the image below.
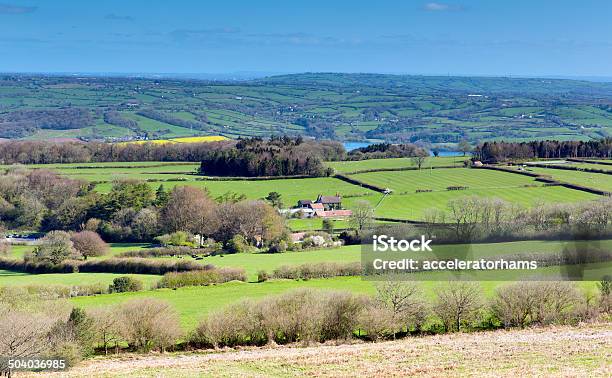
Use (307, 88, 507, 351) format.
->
(191, 289, 365, 347)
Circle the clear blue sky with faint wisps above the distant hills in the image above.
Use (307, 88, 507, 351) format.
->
(0, 0, 612, 77)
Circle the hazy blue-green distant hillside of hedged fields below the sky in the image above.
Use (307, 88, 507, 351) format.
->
(0, 73, 612, 144)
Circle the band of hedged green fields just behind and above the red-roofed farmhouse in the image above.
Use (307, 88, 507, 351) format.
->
(0, 157, 612, 221)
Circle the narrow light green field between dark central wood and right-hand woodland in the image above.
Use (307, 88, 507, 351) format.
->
(325, 156, 469, 173)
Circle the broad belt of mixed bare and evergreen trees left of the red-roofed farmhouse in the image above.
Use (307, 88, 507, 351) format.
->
(0, 169, 286, 248)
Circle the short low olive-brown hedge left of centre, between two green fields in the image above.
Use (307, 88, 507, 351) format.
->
(158, 268, 247, 289)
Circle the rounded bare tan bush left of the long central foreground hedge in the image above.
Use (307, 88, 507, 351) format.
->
(118, 298, 182, 352)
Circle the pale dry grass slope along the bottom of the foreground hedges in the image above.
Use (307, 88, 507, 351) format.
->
(21, 323, 612, 377)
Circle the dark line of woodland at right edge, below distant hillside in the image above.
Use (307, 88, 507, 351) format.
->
(474, 138, 612, 163)
